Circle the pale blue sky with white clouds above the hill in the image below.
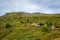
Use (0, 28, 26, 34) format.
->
(0, 0, 60, 15)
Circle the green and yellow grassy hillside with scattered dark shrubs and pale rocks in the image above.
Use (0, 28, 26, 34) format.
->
(0, 12, 60, 40)
